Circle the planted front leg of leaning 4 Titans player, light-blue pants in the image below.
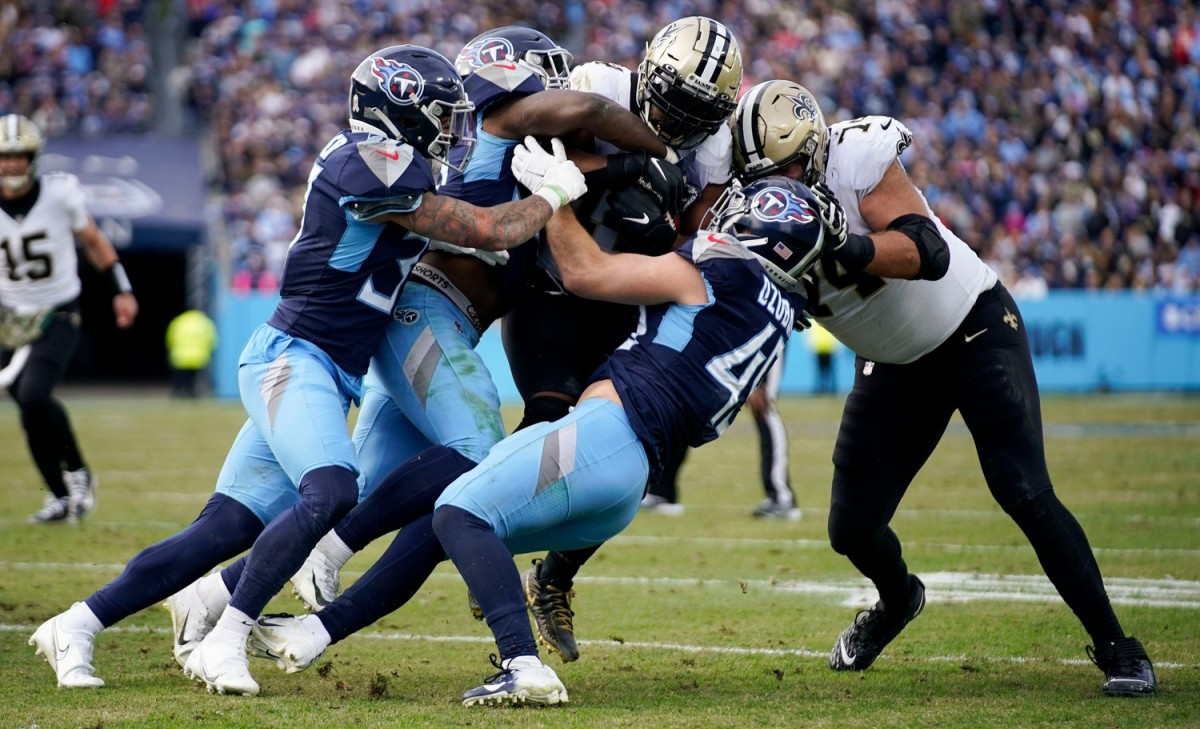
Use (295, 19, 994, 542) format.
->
(433, 399, 648, 704)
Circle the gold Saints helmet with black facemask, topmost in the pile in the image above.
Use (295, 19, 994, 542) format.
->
(637, 16, 742, 150)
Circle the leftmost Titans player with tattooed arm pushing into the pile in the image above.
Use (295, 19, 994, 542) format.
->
(30, 46, 586, 695)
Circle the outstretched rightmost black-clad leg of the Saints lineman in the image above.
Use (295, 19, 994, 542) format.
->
(952, 288, 1157, 694)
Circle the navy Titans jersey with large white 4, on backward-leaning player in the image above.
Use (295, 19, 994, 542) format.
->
(593, 231, 803, 482)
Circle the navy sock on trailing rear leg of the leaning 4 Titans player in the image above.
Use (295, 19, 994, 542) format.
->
(317, 513, 446, 643)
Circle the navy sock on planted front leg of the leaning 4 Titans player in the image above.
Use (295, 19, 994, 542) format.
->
(433, 505, 538, 661)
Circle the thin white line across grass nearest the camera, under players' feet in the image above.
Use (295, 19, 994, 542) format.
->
(0, 623, 1200, 670)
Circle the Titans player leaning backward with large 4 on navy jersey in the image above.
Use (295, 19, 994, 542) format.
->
(243, 170, 824, 706)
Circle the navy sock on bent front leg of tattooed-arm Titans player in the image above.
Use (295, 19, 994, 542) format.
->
(229, 466, 359, 617)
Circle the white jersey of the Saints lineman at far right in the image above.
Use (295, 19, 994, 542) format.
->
(809, 116, 997, 365)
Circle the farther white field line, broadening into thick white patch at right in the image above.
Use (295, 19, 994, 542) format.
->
(9, 562, 1200, 609)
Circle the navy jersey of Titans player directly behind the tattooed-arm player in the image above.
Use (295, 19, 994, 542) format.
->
(438, 62, 545, 312)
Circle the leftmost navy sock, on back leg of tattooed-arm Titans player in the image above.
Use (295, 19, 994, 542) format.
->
(84, 494, 263, 627)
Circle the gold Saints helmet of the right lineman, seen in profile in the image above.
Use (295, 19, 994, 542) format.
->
(730, 79, 829, 185)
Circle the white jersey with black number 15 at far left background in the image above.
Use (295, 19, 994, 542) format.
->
(0, 173, 88, 311)
